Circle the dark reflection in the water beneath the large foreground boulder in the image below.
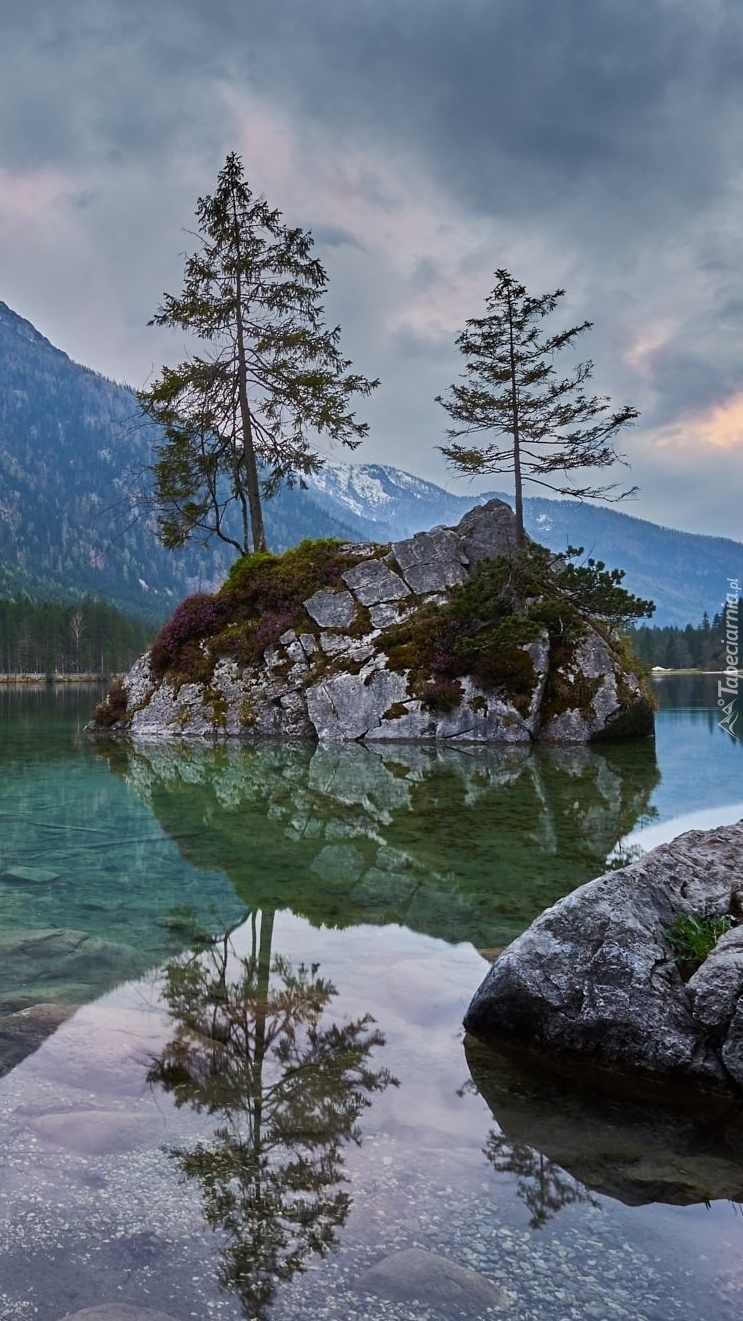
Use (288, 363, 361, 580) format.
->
(465, 1038, 743, 1210)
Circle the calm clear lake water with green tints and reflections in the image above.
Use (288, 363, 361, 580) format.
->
(0, 676, 743, 1321)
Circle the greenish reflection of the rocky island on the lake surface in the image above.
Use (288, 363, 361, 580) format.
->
(100, 740, 660, 947)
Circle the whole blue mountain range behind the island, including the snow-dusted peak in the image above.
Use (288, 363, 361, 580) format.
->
(0, 303, 743, 626)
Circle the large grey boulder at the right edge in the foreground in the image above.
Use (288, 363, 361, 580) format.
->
(464, 822, 743, 1092)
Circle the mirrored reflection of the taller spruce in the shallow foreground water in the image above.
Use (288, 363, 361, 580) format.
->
(148, 913, 397, 1321)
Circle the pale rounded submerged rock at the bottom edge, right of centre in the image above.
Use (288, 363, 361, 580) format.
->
(357, 1247, 508, 1316)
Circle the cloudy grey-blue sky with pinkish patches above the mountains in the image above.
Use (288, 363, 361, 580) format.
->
(0, 0, 743, 538)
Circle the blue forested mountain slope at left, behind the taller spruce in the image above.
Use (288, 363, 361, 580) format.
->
(0, 303, 357, 620)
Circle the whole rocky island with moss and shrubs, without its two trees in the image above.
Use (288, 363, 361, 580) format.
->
(89, 499, 653, 744)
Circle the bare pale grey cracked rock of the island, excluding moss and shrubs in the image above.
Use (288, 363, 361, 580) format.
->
(95, 501, 653, 742)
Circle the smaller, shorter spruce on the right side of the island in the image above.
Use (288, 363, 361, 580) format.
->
(436, 271, 639, 546)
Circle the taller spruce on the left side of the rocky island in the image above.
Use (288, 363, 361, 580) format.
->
(139, 152, 378, 553)
